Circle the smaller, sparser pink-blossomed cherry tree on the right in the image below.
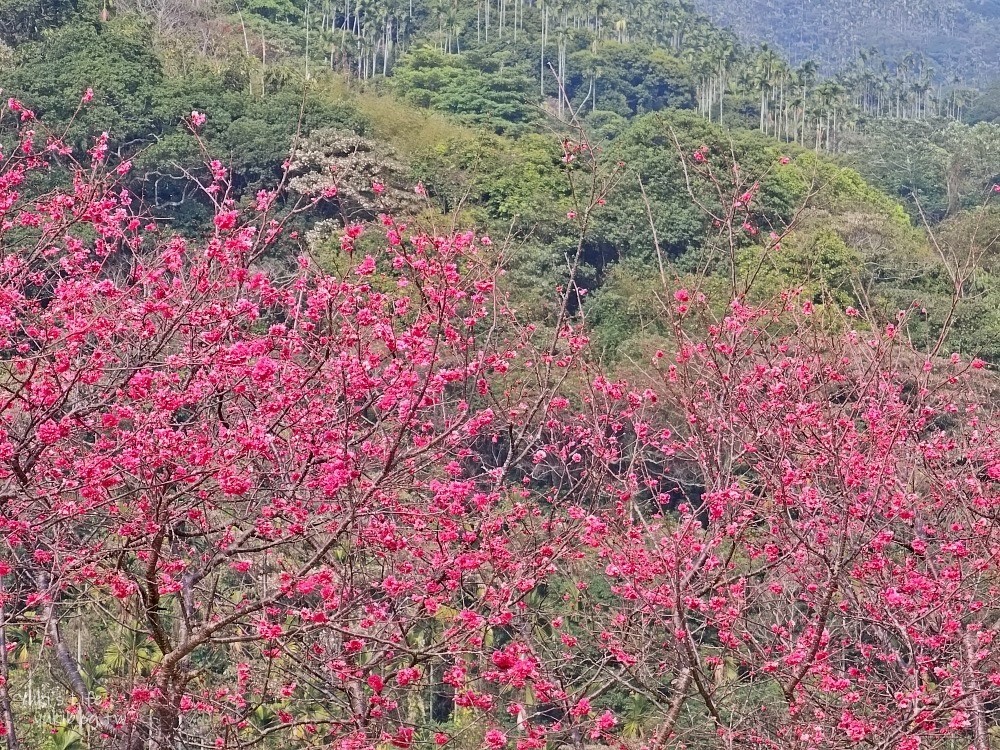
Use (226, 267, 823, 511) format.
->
(580, 290, 1000, 750)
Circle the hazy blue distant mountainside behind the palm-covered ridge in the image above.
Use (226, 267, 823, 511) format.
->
(695, 0, 1000, 84)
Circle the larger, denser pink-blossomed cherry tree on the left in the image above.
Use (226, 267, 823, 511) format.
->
(0, 102, 624, 748)
